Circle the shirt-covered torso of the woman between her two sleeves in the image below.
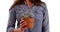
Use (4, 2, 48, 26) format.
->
(16, 4, 43, 32)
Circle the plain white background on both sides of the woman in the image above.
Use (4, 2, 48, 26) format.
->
(0, 0, 60, 32)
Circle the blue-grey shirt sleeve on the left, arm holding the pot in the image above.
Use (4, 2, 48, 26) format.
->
(6, 8, 16, 32)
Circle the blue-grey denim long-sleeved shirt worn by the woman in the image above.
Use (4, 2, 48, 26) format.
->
(6, 4, 49, 32)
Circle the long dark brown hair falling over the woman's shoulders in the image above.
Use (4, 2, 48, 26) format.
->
(9, 0, 43, 10)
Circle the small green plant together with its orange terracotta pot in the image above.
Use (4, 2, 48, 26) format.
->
(21, 11, 34, 29)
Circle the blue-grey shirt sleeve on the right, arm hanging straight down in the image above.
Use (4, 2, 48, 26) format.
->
(42, 4, 49, 32)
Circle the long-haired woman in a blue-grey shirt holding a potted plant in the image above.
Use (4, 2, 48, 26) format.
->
(7, 0, 49, 32)
